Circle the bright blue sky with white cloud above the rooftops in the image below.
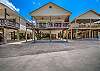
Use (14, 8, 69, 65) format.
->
(0, 0, 100, 20)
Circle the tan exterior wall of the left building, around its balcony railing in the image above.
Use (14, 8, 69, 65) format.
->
(0, 3, 32, 43)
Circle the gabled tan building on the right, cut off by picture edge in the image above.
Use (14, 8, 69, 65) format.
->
(70, 10, 100, 39)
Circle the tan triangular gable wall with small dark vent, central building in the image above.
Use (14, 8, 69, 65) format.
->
(31, 3, 70, 16)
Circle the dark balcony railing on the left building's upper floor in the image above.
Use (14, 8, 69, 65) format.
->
(0, 19, 20, 29)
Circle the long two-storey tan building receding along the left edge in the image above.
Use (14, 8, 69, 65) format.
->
(0, 3, 32, 43)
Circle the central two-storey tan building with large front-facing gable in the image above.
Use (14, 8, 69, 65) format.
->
(30, 2, 71, 40)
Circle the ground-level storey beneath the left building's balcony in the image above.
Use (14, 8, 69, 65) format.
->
(0, 27, 32, 44)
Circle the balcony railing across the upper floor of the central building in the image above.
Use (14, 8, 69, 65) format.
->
(36, 22, 69, 28)
